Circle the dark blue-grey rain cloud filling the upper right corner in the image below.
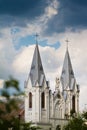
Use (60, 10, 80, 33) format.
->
(46, 0, 87, 34)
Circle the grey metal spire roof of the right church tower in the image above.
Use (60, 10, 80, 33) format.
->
(61, 48, 75, 90)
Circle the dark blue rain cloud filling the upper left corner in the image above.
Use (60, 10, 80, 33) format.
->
(0, 0, 48, 28)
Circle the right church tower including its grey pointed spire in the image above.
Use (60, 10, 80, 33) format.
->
(61, 47, 79, 116)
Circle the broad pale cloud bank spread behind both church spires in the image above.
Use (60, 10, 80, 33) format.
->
(0, 28, 87, 109)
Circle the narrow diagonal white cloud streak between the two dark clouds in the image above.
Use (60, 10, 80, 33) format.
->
(7, 0, 59, 43)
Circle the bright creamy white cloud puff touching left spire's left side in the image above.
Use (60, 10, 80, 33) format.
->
(12, 45, 34, 74)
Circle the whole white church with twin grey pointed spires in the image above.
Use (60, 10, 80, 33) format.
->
(24, 44, 79, 130)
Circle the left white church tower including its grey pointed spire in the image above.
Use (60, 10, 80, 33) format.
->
(25, 44, 49, 123)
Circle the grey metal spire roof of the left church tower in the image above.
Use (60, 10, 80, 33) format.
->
(29, 44, 45, 86)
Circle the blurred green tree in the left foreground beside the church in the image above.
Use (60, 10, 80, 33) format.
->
(0, 77, 37, 130)
